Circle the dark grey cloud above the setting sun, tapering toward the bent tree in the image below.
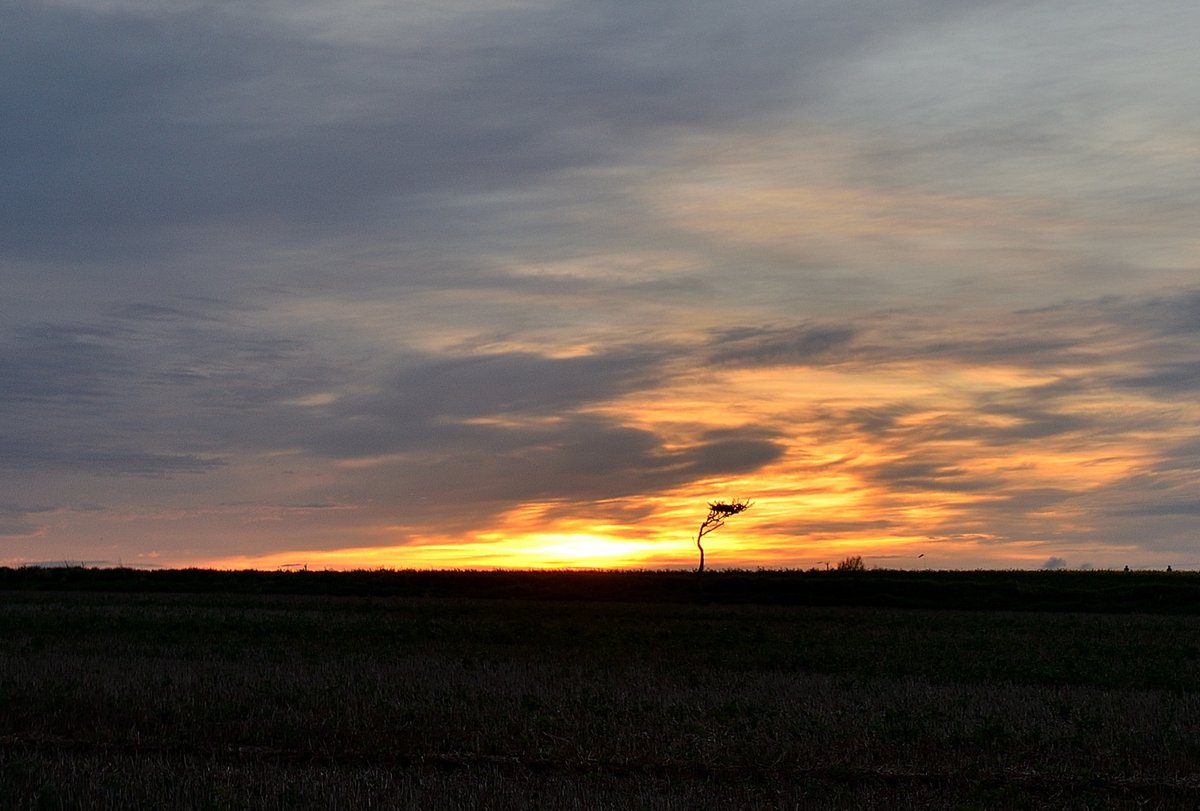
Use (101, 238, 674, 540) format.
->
(296, 354, 784, 529)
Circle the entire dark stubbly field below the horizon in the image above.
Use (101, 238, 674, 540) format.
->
(0, 569, 1200, 809)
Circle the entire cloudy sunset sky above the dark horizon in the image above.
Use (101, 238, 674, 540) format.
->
(0, 0, 1200, 569)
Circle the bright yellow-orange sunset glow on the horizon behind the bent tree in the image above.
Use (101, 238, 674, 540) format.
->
(121, 340, 1200, 570)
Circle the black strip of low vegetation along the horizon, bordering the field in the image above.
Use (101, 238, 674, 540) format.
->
(0, 566, 1200, 614)
